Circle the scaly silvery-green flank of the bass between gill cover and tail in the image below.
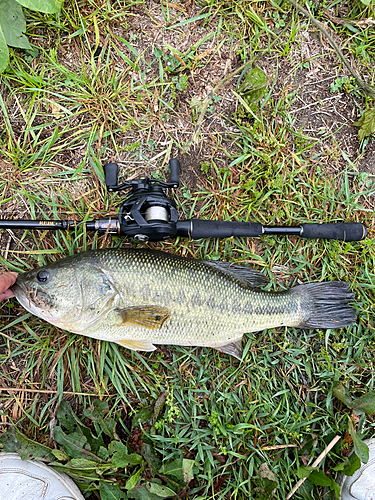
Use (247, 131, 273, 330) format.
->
(80, 250, 301, 346)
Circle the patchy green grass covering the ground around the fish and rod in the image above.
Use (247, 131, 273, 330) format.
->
(0, 0, 375, 500)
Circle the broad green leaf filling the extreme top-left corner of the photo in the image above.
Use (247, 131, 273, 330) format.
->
(0, 0, 31, 49)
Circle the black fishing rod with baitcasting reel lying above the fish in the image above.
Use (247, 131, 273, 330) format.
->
(0, 159, 367, 242)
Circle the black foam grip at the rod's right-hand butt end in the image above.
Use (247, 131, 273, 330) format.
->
(301, 222, 367, 241)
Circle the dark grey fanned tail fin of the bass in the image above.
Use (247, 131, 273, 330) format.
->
(292, 281, 356, 328)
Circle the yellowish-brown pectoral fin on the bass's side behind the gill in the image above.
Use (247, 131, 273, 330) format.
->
(116, 306, 171, 330)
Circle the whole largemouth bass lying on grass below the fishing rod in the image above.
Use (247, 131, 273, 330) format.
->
(13, 248, 356, 359)
